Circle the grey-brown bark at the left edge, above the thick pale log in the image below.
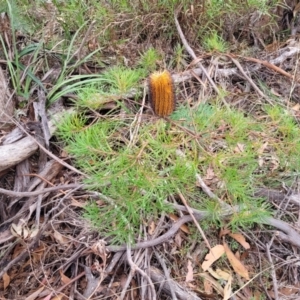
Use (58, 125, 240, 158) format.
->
(0, 67, 14, 130)
